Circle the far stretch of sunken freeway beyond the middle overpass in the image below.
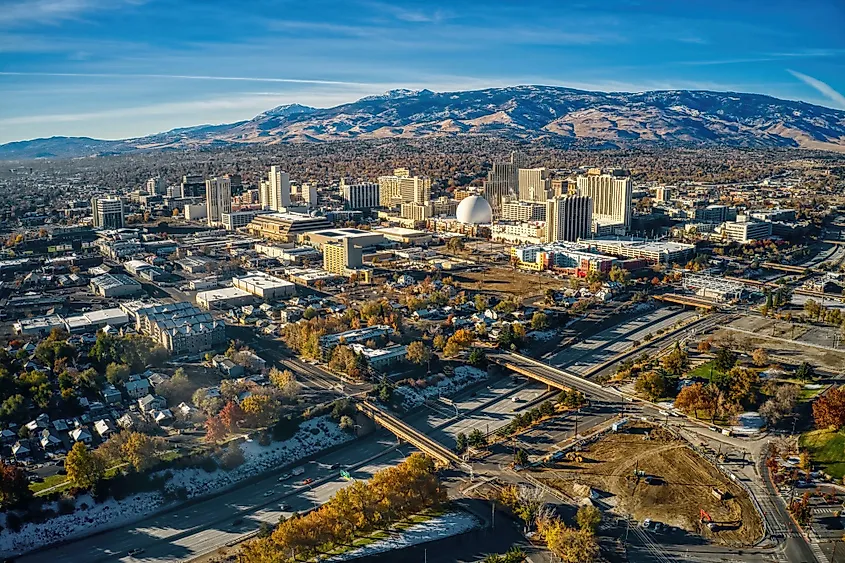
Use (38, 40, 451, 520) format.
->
(543, 307, 697, 375)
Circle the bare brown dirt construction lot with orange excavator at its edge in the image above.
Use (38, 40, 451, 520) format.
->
(538, 423, 763, 546)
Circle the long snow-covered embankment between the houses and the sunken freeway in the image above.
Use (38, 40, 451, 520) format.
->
(0, 416, 354, 556)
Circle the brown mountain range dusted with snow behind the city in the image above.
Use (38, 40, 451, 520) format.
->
(0, 86, 845, 160)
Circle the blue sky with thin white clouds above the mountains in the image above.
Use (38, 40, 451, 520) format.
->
(0, 0, 845, 142)
